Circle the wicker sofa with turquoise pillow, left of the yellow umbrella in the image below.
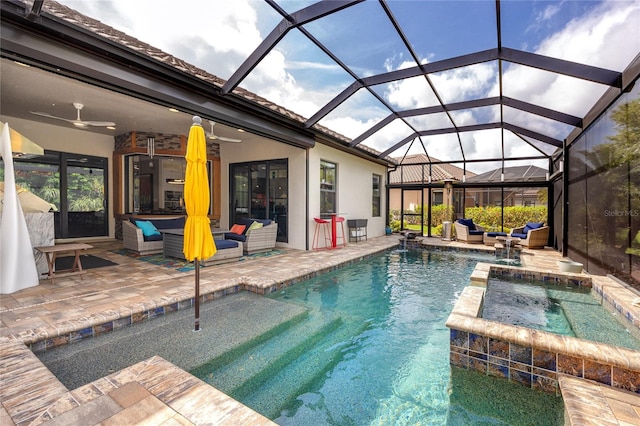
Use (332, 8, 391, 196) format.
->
(122, 216, 185, 256)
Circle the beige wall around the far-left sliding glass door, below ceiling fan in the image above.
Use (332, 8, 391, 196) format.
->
(0, 115, 115, 238)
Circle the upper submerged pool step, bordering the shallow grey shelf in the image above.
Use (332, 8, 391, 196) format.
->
(193, 311, 342, 399)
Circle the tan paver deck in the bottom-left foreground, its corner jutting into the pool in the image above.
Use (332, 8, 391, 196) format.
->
(0, 338, 275, 425)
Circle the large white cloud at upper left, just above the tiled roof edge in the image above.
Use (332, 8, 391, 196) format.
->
(61, 0, 262, 78)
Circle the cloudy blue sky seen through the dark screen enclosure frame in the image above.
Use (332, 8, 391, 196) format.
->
(60, 0, 640, 172)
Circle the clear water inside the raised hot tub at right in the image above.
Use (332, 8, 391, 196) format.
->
(482, 278, 640, 350)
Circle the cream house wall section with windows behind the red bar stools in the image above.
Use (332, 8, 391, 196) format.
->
(307, 144, 387, 246)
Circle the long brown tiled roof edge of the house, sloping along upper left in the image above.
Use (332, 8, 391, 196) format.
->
(43, 0, 395, 164)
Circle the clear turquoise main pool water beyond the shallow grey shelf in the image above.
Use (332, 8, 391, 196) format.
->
(191, 250, 564, 425)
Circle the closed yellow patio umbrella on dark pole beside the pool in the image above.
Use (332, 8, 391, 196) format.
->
(183, 116, 216, 331)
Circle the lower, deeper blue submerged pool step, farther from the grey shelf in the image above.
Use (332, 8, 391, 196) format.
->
(240, 323, 367, 419)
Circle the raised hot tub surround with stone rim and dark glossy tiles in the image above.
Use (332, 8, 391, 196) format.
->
(446, 264, 640, 393)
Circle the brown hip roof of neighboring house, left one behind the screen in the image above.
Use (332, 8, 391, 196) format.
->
(389, 154, 476, 184)
